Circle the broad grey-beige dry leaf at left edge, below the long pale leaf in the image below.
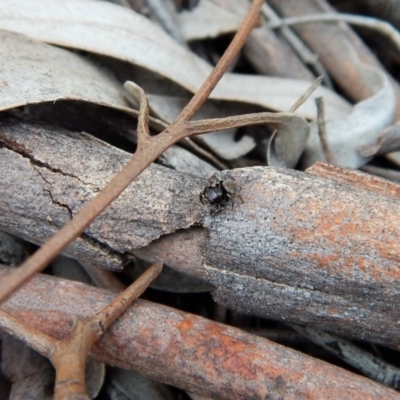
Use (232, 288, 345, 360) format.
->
(0, 31, 137, 115)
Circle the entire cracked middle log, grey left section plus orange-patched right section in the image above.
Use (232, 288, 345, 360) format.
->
(0, 114, 400, 348)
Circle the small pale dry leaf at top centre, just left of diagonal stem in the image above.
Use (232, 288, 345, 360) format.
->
(178, 0, 242, 41)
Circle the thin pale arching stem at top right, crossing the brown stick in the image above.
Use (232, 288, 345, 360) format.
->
(269, 14, 400, 51)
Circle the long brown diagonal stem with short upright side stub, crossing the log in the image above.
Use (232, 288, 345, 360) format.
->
(0, 0, 264, 302)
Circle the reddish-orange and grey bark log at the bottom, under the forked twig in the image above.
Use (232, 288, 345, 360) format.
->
(0, 269, 400, 400)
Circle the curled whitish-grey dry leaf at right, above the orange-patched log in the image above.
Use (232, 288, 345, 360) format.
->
(303, 61, 396, 169)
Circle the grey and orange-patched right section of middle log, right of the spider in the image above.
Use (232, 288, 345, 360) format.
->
(204, 167, 400, 348)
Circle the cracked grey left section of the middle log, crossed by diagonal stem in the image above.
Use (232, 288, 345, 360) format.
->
(0, 115, 204, 269)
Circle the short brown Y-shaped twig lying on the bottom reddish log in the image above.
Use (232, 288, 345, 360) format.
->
(0, 263, 162, 400)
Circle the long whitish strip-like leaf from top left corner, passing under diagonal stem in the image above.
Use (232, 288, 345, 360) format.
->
(0, 0, 351, 118)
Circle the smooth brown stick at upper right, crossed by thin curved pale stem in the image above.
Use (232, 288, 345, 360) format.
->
(269, 0, 400, 118)
